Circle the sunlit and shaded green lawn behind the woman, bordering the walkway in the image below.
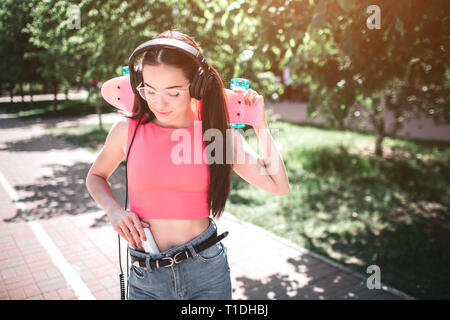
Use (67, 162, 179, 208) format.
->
(47, 116, 450, 299)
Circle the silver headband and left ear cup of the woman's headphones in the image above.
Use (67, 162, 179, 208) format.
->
(128, 38, 210, 94)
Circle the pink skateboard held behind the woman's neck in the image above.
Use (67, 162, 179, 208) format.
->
(101, 75, 262, 128)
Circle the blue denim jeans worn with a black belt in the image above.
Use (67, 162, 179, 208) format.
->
(128, 218, 231, 300)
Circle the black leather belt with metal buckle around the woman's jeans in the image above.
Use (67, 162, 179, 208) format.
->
(130, 231, 228, 268)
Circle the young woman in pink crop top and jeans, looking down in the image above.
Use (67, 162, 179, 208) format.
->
(86, 30, 290, 299)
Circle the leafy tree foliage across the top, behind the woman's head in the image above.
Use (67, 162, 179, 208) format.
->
(0, 0, 450, 145)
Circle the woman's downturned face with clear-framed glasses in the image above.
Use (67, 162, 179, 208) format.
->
(142, 64, 191, 126)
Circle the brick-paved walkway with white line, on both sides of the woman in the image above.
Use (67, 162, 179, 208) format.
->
(0, 115, 411, 300)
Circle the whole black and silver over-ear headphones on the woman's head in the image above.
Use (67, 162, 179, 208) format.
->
(128, 38, 213, 100)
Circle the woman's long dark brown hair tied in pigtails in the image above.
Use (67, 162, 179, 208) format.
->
(122, 29, 233, 218)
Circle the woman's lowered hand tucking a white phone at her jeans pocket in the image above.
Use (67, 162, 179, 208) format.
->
(108, 209, 150, 249)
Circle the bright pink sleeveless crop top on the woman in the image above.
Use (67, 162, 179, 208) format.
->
(127, 119, 210, 220)
